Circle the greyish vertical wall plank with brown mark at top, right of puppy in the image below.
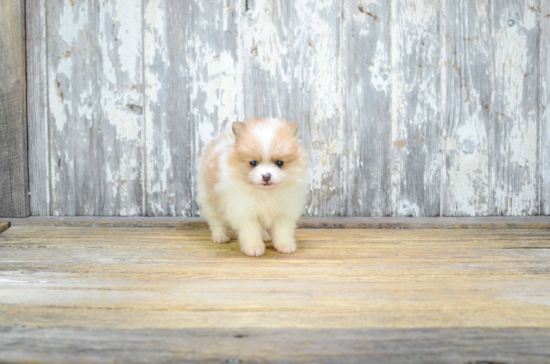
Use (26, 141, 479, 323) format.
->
(342, 0, 391, 216)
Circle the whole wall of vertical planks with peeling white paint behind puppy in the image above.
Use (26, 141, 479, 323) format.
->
(27, 0, 550, 216)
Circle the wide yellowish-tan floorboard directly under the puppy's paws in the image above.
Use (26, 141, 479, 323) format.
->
(0, 226, 550, 329)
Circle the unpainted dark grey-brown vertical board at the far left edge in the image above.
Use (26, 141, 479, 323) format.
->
(0, 0, 29, 217)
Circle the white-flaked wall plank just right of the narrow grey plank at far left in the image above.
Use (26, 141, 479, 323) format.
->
(46, 0, 101, 216)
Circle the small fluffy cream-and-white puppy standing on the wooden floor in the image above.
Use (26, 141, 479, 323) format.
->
(197, 119, 307, 257)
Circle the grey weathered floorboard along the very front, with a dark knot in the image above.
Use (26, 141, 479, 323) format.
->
(0, 325, 550, 363)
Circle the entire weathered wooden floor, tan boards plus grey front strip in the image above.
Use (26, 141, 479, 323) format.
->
(0, 224, 550, 363)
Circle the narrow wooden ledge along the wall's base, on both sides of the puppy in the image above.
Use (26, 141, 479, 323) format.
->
(0, 216, 550, 229)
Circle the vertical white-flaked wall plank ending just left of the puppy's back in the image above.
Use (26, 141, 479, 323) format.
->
(144, 0, 193, 216)
